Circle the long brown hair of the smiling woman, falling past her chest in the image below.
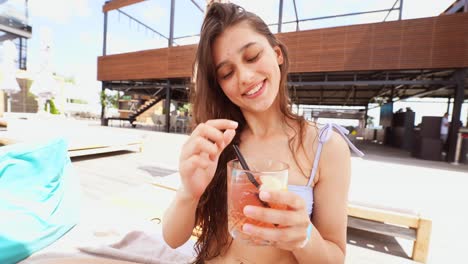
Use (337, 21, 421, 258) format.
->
(191, 3, 306, 263)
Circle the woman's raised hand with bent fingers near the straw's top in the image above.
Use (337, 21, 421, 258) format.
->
(179, 119, 237, 199)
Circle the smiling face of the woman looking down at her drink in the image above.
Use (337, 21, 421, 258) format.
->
(211, 22, 283, 112)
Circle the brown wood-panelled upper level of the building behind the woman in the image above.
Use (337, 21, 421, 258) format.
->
(98, 0, 468, 106)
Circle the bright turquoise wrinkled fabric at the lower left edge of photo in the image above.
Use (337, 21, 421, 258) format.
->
(0, 139, 80, 263)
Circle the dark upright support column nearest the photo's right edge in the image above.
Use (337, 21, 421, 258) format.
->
(447, 69, 466, 162)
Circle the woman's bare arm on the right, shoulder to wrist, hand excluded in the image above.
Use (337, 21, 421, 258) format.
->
(293, 133, 351, 263)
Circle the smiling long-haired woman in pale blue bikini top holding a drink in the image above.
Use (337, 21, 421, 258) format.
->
(163, 3, 364, 263)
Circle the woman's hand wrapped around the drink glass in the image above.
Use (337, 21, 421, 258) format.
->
(242, 191, 311, 251)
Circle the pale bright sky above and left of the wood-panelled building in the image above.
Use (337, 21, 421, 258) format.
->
(24, 0, 454, 113)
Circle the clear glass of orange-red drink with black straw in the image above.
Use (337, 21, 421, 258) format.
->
(227, 159, 289, 245)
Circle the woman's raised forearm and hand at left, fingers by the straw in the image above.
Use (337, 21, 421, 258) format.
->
(163, 119, 237, 248)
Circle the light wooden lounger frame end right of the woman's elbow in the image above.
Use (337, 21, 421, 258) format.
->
(348, 203, 432, 263)
